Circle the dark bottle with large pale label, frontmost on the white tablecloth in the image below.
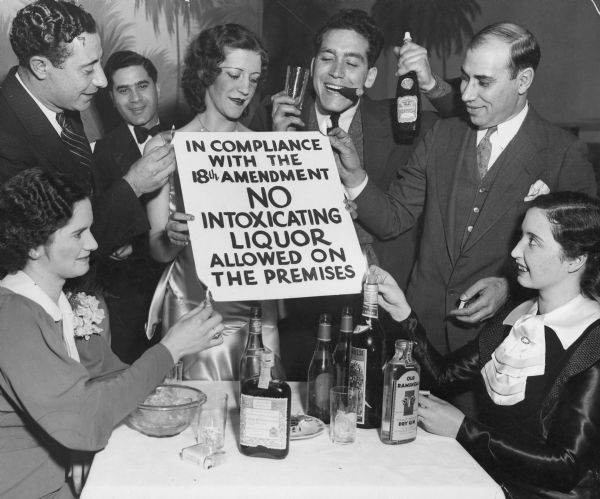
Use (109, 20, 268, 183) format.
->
(240, 351, 292, 459)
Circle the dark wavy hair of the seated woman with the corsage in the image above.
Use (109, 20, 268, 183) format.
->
(0, 168, 89, 277)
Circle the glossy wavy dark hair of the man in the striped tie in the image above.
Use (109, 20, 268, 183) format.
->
(10, 0, 96, 67)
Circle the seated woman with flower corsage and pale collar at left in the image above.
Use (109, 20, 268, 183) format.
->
(0, 168, 223, 498)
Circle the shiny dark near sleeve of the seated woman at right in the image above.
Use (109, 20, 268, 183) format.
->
(456, 363, 600, 491)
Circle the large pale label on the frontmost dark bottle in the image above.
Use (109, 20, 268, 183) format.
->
(240, 394, 288, 449)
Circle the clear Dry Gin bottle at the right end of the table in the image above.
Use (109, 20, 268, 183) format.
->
(379, 340, 420, 444)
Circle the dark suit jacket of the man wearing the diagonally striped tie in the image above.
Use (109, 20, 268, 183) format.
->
(0, 68, 149, 256)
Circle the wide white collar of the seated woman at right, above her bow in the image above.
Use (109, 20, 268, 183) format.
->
(503, 294, 600, 349)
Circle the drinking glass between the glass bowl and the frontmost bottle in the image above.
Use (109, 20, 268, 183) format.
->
(193, 392, 228, 452)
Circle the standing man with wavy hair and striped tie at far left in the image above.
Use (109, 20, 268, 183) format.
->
(0, 0, 175, 258)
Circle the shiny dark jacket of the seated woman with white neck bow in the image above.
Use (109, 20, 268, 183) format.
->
(393, 303, 600, 499)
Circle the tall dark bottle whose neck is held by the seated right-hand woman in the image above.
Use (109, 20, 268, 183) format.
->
(349, 275, 385, 428)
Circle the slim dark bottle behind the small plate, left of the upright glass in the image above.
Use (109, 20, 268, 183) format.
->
(306, 314, 335, 424)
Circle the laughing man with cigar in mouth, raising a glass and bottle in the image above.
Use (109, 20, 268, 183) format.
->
(250, 9, 436, 348)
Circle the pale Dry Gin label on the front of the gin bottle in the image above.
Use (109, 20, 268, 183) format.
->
(390, 369, 419, 442)
